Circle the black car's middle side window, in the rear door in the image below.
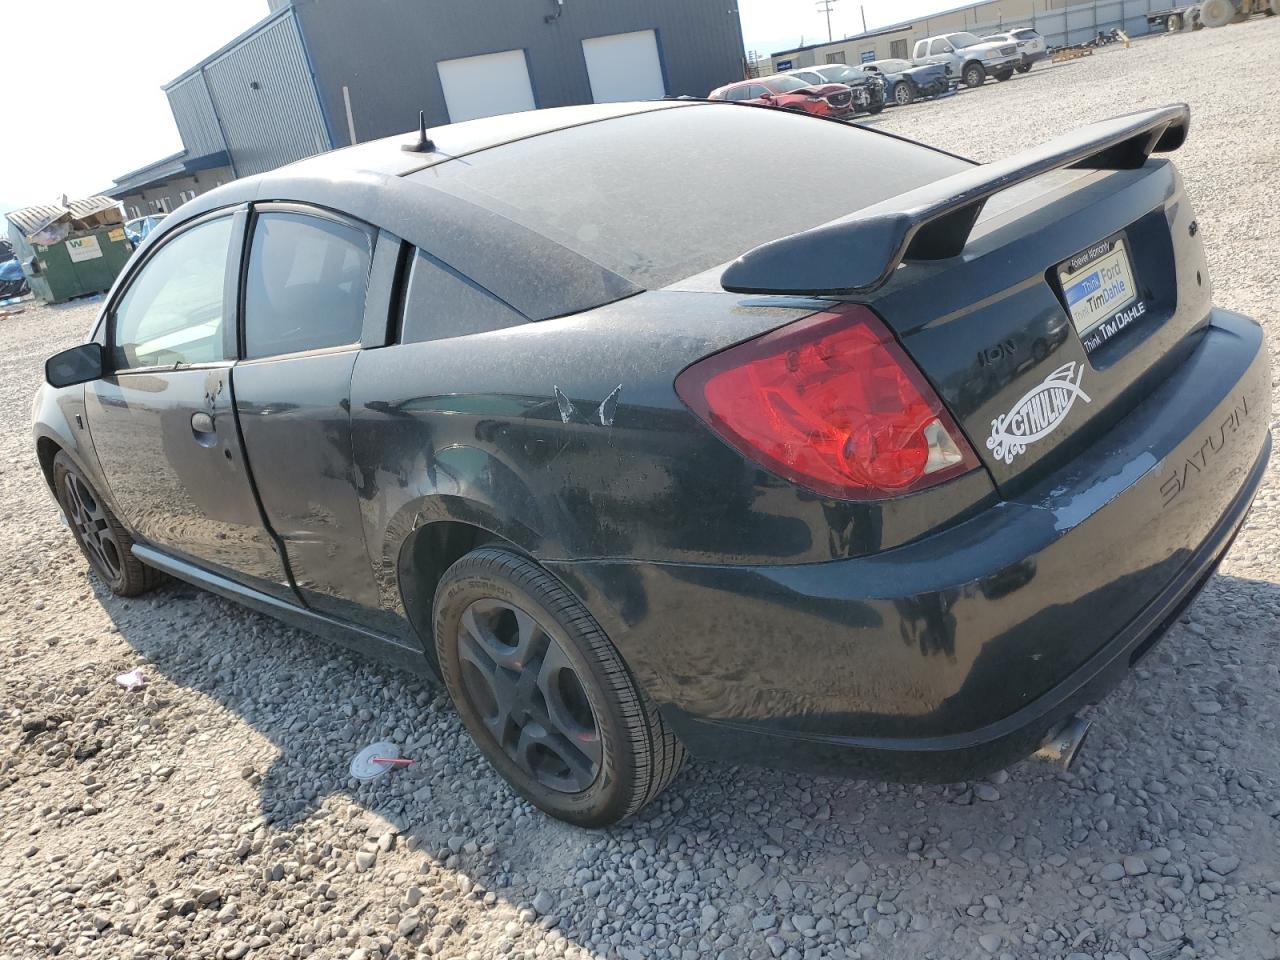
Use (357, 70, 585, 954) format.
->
(244, 211, 372, 360)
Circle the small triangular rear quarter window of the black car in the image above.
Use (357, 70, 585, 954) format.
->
(401, 251, 527, 343)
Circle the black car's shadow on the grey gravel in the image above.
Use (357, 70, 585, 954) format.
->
(93, 563, 1280, 955)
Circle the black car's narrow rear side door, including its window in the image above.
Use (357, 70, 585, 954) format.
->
(232, 204, 399, 620)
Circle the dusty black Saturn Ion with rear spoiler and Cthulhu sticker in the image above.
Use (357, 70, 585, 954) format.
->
(35, 101, 1271, 824)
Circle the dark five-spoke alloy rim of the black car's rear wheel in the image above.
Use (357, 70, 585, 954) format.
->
(457, 598, 604, 794)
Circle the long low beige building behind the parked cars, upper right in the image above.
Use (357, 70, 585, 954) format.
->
(769, 0, 1175, 73)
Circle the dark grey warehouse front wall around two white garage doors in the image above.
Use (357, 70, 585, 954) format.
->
(293, 0, 742, 145)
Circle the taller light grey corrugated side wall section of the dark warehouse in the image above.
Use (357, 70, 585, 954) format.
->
(202, 13, 333, 177)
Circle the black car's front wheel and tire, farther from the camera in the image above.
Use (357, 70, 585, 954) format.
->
(54, 452, 160, 596)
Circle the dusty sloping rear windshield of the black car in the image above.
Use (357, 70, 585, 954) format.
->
(411, 105, 968, 289)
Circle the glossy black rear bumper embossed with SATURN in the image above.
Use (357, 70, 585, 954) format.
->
(549, 311, 1271, 781)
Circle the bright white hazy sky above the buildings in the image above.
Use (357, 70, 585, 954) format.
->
(0, 0, 957, 212)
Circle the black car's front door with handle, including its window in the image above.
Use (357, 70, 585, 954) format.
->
(84, 207, 293, 596)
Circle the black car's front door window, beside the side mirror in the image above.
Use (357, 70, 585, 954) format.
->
(111, 216, 232, 370)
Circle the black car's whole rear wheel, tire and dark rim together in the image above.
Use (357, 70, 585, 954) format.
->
(433, 547, 685, 827)
